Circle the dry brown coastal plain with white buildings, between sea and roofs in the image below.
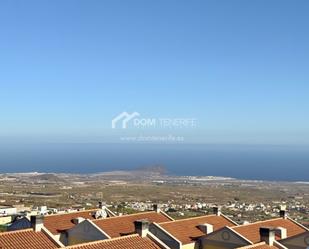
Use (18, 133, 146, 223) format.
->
(0, 166, 309, 225)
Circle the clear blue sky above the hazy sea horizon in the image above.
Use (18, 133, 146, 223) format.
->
(0, 0, 309, 144)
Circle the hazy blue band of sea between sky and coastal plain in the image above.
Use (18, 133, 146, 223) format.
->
(0, 143, 309, 181)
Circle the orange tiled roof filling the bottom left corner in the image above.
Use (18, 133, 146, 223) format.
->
(0, 229, 57, 249)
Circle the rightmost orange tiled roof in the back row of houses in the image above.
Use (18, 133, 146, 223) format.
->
(233, 218, 306, 243)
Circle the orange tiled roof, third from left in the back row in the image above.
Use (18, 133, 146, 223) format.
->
(159, 215, 235, 244)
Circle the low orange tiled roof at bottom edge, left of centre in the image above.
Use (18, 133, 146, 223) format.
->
(66, 235, 160, 249)
